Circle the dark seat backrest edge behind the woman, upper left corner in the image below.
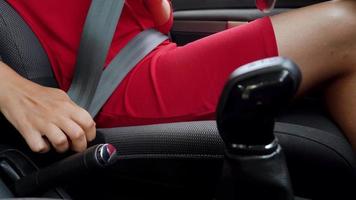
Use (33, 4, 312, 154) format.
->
(0, 0, 56, 87)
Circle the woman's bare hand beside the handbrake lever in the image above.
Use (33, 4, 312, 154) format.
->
(0, 62, 96, 152)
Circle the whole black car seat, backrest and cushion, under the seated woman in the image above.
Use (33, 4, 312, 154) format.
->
(0, 0, 356, 199)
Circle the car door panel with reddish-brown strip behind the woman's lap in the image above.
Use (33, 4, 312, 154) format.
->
(171, 0, 321, 45)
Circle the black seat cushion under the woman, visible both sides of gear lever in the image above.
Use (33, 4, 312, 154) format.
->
(98, 115, 356, 199)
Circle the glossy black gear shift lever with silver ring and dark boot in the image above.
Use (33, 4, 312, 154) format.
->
(217, 57, 301, 200)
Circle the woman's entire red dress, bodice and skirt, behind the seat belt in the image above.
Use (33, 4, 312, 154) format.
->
(4, 0, 278, 127)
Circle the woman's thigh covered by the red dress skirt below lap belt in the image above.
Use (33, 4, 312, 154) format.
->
(99, 18, 278, 126)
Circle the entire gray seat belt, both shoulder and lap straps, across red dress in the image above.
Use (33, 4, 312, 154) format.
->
(68, 0, 168, 117)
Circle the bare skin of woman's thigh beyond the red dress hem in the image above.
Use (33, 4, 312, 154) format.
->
(271, 1, 356, 93)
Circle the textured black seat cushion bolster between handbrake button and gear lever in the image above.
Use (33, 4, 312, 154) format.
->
(99, 121, 224, 158)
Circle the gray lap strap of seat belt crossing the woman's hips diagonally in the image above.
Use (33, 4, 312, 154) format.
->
(88, 29, 168, 117)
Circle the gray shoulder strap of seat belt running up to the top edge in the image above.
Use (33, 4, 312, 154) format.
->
(68, 0, 124, 109)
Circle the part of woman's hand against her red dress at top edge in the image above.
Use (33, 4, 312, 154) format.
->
(144, 0, 171, 26)
